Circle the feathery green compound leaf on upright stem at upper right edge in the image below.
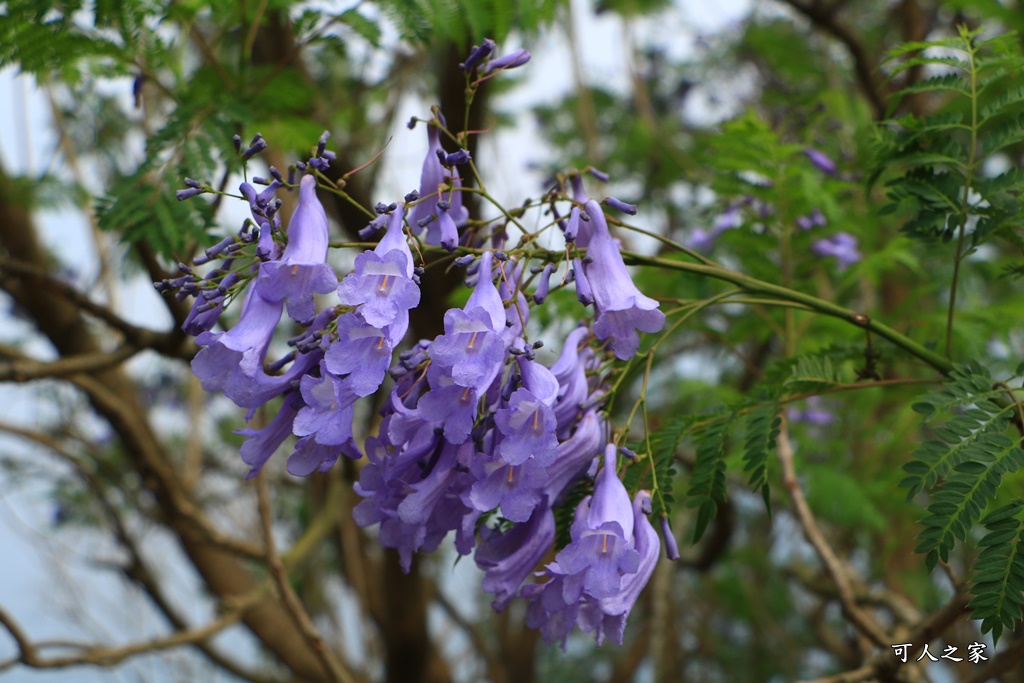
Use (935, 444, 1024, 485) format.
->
(876, 30, 1024, 253)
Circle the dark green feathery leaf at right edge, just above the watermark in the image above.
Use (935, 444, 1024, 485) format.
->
(968, 499, 1024, 643)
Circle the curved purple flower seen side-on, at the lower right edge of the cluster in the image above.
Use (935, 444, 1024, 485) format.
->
(577, 490, 660, 645)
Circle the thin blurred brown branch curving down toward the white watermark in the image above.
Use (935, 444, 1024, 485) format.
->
(776, 420, 890, 647)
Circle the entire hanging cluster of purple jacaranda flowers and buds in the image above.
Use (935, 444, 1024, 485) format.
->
(158, 41, 675, 644)
